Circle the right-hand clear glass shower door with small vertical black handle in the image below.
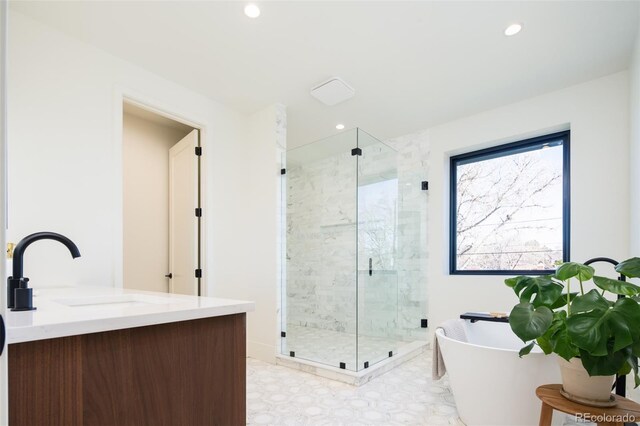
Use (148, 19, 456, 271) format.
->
(357, 129, 399, 370)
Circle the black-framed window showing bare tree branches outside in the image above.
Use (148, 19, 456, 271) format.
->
(449, 131, 569, 275)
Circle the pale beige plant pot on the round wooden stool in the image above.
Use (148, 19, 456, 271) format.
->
(558, 357, 616, 407)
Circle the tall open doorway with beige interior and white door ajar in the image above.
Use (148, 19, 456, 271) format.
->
(122, 101, 202, 296)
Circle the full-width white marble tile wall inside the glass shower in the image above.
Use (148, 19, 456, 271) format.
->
(283, 133, 429, 341)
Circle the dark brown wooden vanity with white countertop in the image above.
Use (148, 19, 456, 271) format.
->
(6, 288, 254, 426)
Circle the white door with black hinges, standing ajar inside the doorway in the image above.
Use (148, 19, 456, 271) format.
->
(169, 130, 199, 296)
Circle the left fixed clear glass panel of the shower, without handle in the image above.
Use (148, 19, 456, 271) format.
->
(281, 129, 357, 371)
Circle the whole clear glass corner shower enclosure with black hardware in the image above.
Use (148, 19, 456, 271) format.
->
(281, 128, 426, 371)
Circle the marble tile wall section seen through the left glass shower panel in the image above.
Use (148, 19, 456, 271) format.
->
(286, 150, 356, 333)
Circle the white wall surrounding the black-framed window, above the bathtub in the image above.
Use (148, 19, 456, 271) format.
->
(427, 72, 629, 330)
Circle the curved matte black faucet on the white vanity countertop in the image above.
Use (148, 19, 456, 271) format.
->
(7, 232, 80, 311)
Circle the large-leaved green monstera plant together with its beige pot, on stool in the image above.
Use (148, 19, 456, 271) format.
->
(505, 257, 640, 406)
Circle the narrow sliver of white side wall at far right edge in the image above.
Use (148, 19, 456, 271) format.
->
(629, 22, 640, 256)
